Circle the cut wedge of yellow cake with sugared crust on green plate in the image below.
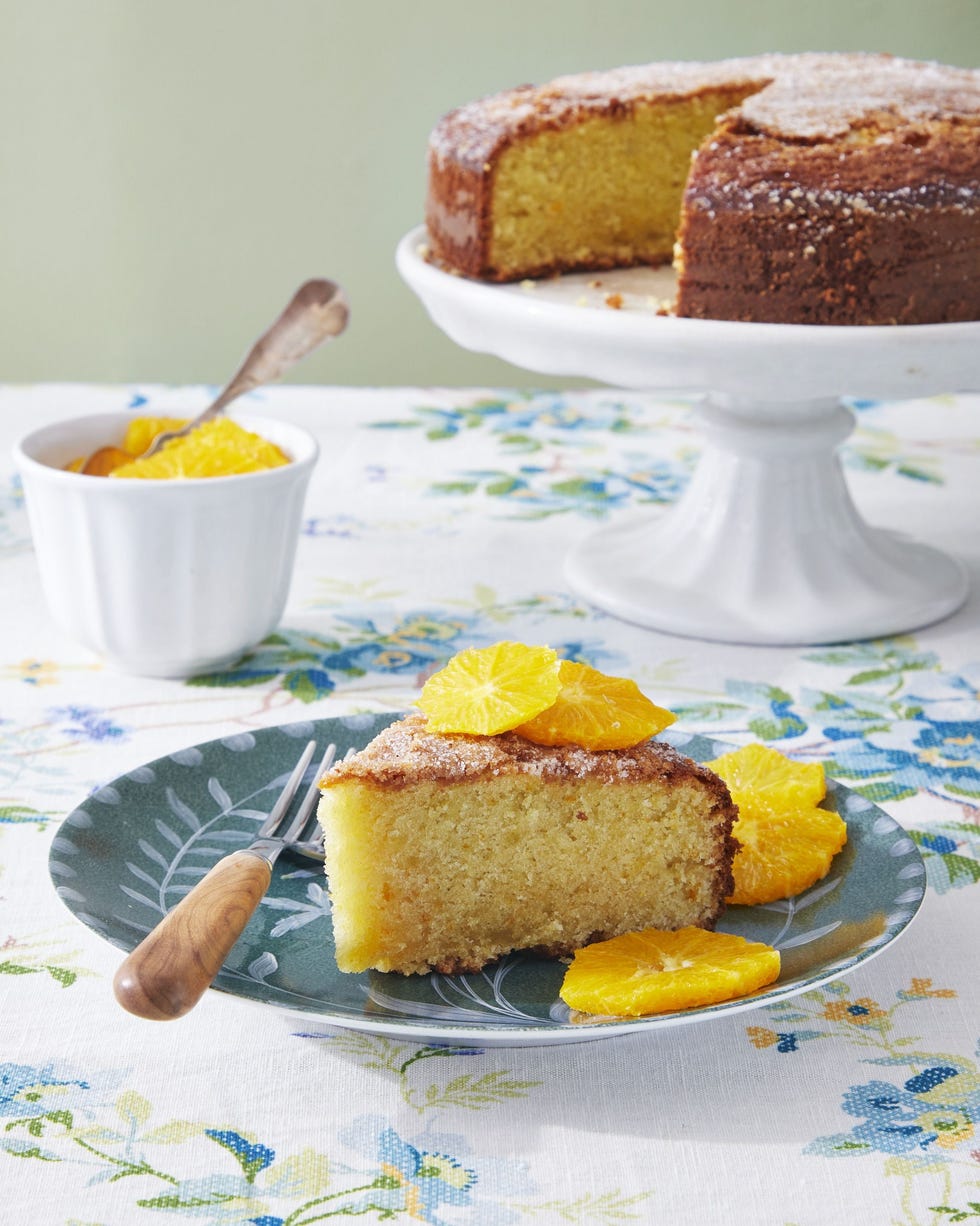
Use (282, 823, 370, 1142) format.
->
(319, 715, 736, 973)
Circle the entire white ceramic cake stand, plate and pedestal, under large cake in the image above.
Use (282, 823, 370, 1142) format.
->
(396, 228, 980, 644)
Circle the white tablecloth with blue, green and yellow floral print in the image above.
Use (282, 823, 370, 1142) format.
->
(0, 386, 980, 1226)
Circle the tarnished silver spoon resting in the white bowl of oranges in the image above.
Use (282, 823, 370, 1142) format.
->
(80, 277, 351, 477)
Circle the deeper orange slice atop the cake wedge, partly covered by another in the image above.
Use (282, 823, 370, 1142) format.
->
(516, 660, 677, 749)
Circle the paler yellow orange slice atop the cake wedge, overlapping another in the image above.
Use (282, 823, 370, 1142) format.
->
(417, 641, 561, 737)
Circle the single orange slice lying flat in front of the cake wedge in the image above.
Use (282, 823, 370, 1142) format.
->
(559, 928, 779, 1018)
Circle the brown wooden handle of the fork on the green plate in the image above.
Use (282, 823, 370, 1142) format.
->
(113, 851, 272, 1021)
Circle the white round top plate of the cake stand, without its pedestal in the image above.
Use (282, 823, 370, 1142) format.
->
(396, 226, 980, 402)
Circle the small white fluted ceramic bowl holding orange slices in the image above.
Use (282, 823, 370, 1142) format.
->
(13, 413, 318, 677)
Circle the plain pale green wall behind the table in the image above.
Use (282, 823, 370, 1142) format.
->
(0, 0, 980, 386)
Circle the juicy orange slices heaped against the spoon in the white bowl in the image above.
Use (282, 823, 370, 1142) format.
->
(112, 417, 289, 481)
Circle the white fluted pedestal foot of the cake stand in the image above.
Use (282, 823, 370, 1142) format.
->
(565, 396, 969, 645)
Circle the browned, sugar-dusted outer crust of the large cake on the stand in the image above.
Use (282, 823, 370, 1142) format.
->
(427, 54, 980, 324)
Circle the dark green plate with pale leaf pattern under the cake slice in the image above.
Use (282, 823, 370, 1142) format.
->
(49, 714, 926, 1047)
